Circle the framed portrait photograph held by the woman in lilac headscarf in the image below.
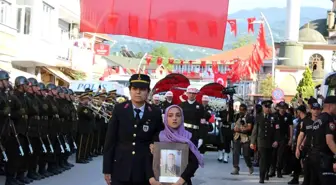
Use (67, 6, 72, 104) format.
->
(153, 142, 189, 185)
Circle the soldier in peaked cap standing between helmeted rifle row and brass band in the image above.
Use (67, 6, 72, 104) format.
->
(76, 92, 95, 163)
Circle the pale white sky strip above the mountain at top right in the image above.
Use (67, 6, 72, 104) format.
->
(229, 0, 332, 13)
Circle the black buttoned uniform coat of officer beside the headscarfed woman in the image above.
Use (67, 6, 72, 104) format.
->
(103, 101, 164, 182)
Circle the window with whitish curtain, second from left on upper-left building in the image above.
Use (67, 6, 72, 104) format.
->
(16, 6, 31, 35)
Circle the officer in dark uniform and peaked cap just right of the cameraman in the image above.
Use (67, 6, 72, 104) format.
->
(251, 100, 279, 183)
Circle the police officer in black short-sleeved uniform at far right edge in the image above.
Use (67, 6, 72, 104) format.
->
(308, 96, 336, 185)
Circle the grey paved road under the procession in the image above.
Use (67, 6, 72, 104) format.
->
(0, 152, 289, 185)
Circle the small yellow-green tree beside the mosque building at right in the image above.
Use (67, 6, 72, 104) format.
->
(296, 67, 314, 98)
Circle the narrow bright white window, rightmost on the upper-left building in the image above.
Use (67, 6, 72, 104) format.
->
(41, 2, 54, 38)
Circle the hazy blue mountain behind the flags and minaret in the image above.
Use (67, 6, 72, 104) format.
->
(111, 7, 327, 59)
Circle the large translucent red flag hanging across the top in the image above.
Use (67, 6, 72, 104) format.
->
(80, 0, 229, 49)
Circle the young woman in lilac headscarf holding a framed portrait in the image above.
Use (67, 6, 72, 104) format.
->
(150, 105, 204, 185)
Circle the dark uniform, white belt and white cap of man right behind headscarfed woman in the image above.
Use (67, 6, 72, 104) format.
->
(180, 86, 208, 147)
